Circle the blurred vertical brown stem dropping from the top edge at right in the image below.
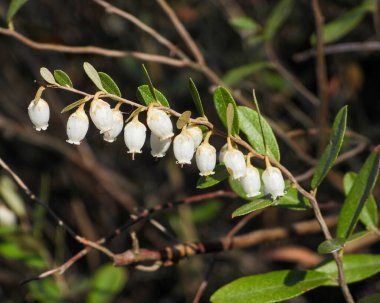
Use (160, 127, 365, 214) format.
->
(312, 0, 329, 154)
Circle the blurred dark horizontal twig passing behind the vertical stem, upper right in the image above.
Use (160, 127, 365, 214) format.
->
(293, 41, 380, 62)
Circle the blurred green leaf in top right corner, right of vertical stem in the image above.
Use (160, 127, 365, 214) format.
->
(310, 0, 374, 45)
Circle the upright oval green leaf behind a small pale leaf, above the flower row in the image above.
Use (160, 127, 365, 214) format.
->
(214, 86, 239, 135)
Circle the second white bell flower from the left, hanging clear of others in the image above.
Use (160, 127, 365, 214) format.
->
(66, 106, 90, 145)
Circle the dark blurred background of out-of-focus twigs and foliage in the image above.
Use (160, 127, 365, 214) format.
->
(0, 0, 380, 302)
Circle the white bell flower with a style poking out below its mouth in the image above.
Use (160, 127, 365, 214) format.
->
(124, 115, 146, 159)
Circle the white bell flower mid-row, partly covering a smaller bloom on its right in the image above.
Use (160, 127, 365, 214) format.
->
(173, 127, 195, 166)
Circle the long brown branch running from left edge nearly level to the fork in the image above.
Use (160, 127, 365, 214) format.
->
(0, 27, 187, 67)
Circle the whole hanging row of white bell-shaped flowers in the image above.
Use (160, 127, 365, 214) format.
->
(28, 95, 285, 199)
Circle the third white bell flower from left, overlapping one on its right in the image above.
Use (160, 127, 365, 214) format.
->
(90, 99, 113, 134)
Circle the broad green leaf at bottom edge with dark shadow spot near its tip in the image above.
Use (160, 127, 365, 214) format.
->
(211, 270, 329, 303)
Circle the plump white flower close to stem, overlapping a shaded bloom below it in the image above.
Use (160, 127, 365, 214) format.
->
(147, 107, 174, 140)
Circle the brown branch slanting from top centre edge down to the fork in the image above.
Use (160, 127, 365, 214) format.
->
(156, 0, 205, 65)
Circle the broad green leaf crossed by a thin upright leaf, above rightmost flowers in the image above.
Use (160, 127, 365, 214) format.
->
(237, 106, 280, 161)
